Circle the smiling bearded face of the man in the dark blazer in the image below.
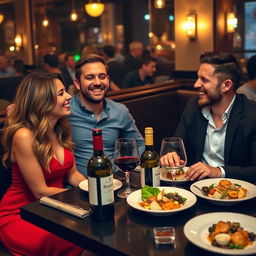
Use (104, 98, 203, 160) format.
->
(194, 63, 223, 107)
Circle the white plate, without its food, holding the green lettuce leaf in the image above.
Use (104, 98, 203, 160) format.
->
(127, 187, 196, 216)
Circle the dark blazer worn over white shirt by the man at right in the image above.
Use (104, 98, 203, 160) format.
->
(175, 94, 256, 183)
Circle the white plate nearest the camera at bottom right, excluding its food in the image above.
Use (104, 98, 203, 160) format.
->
(183, 212, 256, 255)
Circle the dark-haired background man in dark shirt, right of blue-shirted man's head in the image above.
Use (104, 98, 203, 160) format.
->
(122, 55, 156, 89)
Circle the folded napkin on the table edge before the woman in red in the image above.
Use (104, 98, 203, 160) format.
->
(40, 196, 90, 218)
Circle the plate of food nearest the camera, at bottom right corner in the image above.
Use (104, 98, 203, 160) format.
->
(183, 212, 256, 255)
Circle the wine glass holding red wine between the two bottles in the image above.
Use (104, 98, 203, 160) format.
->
(114, 138, 140, 198)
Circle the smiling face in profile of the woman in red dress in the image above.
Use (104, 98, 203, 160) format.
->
(49, 79, 72, 120)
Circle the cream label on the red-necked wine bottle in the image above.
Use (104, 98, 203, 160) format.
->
(88, 174, 114, 205)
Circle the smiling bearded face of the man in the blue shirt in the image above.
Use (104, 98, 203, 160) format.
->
(75, 62, 109, 104)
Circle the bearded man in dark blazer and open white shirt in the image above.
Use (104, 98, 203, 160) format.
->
(161, 53, 256, 182)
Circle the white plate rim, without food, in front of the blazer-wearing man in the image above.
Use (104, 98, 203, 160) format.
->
(190, 178, 256, 205)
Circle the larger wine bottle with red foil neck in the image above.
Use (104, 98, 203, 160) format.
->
(87, 129, 114, 221)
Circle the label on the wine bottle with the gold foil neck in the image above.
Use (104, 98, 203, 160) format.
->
(140, 166, 160, 187)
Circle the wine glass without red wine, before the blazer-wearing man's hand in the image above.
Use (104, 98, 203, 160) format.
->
(160, 137, 187, 186)
